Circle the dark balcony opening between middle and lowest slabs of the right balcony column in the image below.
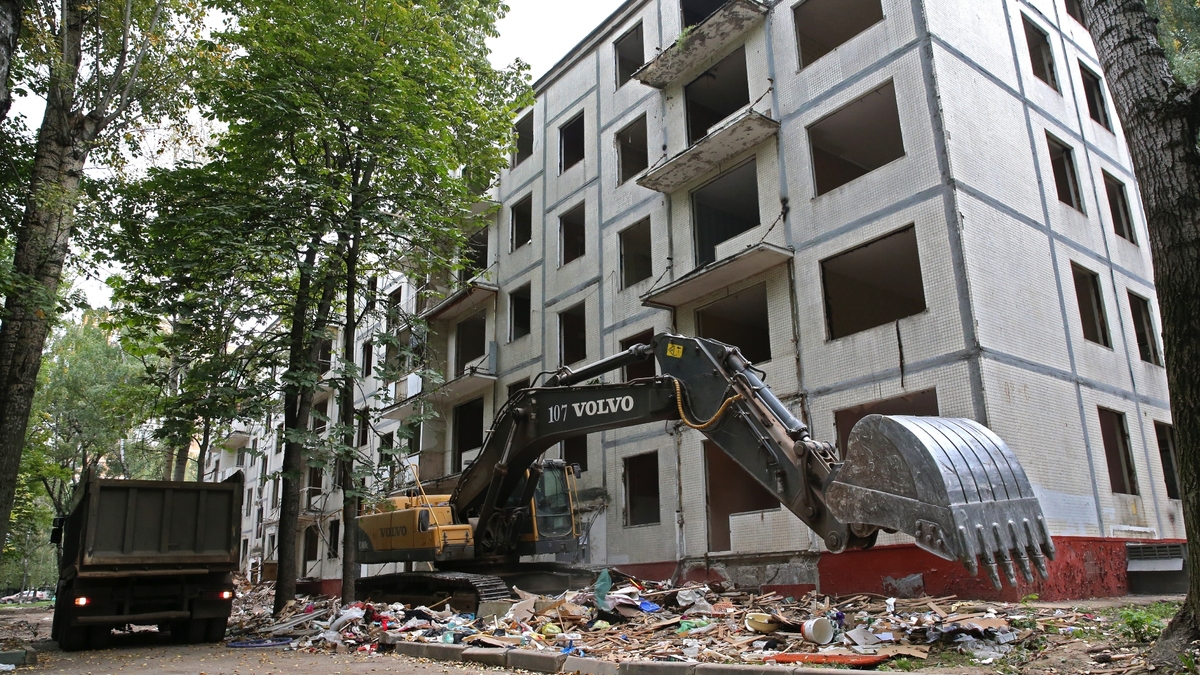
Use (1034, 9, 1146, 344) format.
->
(691, 160, 762, 267)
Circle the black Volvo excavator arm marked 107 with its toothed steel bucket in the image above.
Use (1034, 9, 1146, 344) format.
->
(451, 334, 1055, 589)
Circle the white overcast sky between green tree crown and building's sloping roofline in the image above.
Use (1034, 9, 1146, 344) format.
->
(490, 0, 623, 80)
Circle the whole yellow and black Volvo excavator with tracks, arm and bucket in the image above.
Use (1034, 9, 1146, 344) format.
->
(358, 334, 1055, 610)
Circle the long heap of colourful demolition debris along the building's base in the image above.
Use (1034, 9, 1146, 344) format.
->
(230, 572, 1138, 671)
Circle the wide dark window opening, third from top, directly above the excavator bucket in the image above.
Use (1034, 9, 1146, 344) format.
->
(821, 226, 925, 340)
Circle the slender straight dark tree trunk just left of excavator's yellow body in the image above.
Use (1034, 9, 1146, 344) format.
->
(340, 245, 357, 604)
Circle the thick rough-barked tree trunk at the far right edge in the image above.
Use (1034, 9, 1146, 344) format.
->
(1084, 0, 1200, 667)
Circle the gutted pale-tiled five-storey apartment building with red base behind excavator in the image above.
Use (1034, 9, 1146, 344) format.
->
(211, 0, 1184, 597)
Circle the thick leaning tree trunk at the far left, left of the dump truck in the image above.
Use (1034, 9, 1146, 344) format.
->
(0, 102, 98, 552)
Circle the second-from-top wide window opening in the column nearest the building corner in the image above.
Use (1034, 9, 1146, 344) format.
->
(809, 80, 905, 196)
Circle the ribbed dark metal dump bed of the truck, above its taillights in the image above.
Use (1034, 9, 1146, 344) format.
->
(60, 473, 242, 579)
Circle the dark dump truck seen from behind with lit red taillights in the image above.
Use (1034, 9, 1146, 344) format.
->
(50, 472, 244, 651)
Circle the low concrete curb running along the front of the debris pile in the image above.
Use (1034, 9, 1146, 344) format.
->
(374, 643, 922, 675)
